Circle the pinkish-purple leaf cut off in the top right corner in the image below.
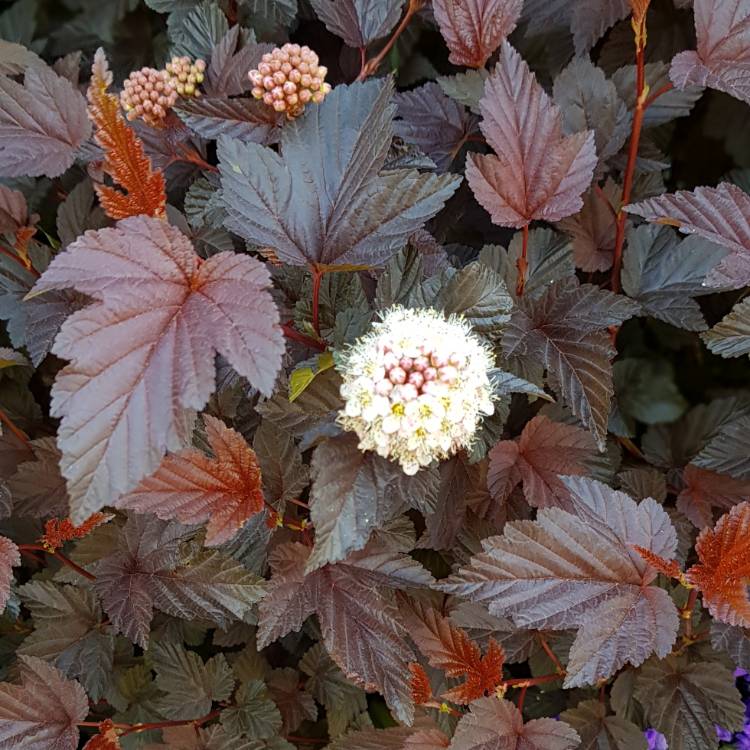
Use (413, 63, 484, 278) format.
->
(669, 0, 750, 103)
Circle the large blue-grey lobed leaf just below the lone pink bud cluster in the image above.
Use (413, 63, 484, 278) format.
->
(218, 80, 460, 266)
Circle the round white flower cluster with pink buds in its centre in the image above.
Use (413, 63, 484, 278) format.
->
(339, 307, 494, 474)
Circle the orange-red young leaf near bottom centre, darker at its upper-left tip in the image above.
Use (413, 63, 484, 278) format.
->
(407, 602, 505, 704)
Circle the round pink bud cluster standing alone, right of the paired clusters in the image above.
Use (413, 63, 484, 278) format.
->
(247, 44, 331, 120)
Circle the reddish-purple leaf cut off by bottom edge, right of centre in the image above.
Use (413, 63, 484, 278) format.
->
(449, 697, 581, 750)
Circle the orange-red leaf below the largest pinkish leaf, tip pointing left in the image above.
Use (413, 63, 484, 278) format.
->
(117, 416, 264, 547)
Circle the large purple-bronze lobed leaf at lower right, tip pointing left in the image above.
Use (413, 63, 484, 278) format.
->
(438, 477, 678, 687)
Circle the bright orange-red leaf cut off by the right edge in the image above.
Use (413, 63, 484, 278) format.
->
(686, 503, 750, 628)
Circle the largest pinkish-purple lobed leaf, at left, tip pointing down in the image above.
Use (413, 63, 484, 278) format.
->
(34, 216, 284, 521)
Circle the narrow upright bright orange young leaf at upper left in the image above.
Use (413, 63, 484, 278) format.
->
(88, 49, 167, 219)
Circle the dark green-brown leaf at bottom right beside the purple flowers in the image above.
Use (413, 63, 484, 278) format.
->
(634, 654, 745, 750)
